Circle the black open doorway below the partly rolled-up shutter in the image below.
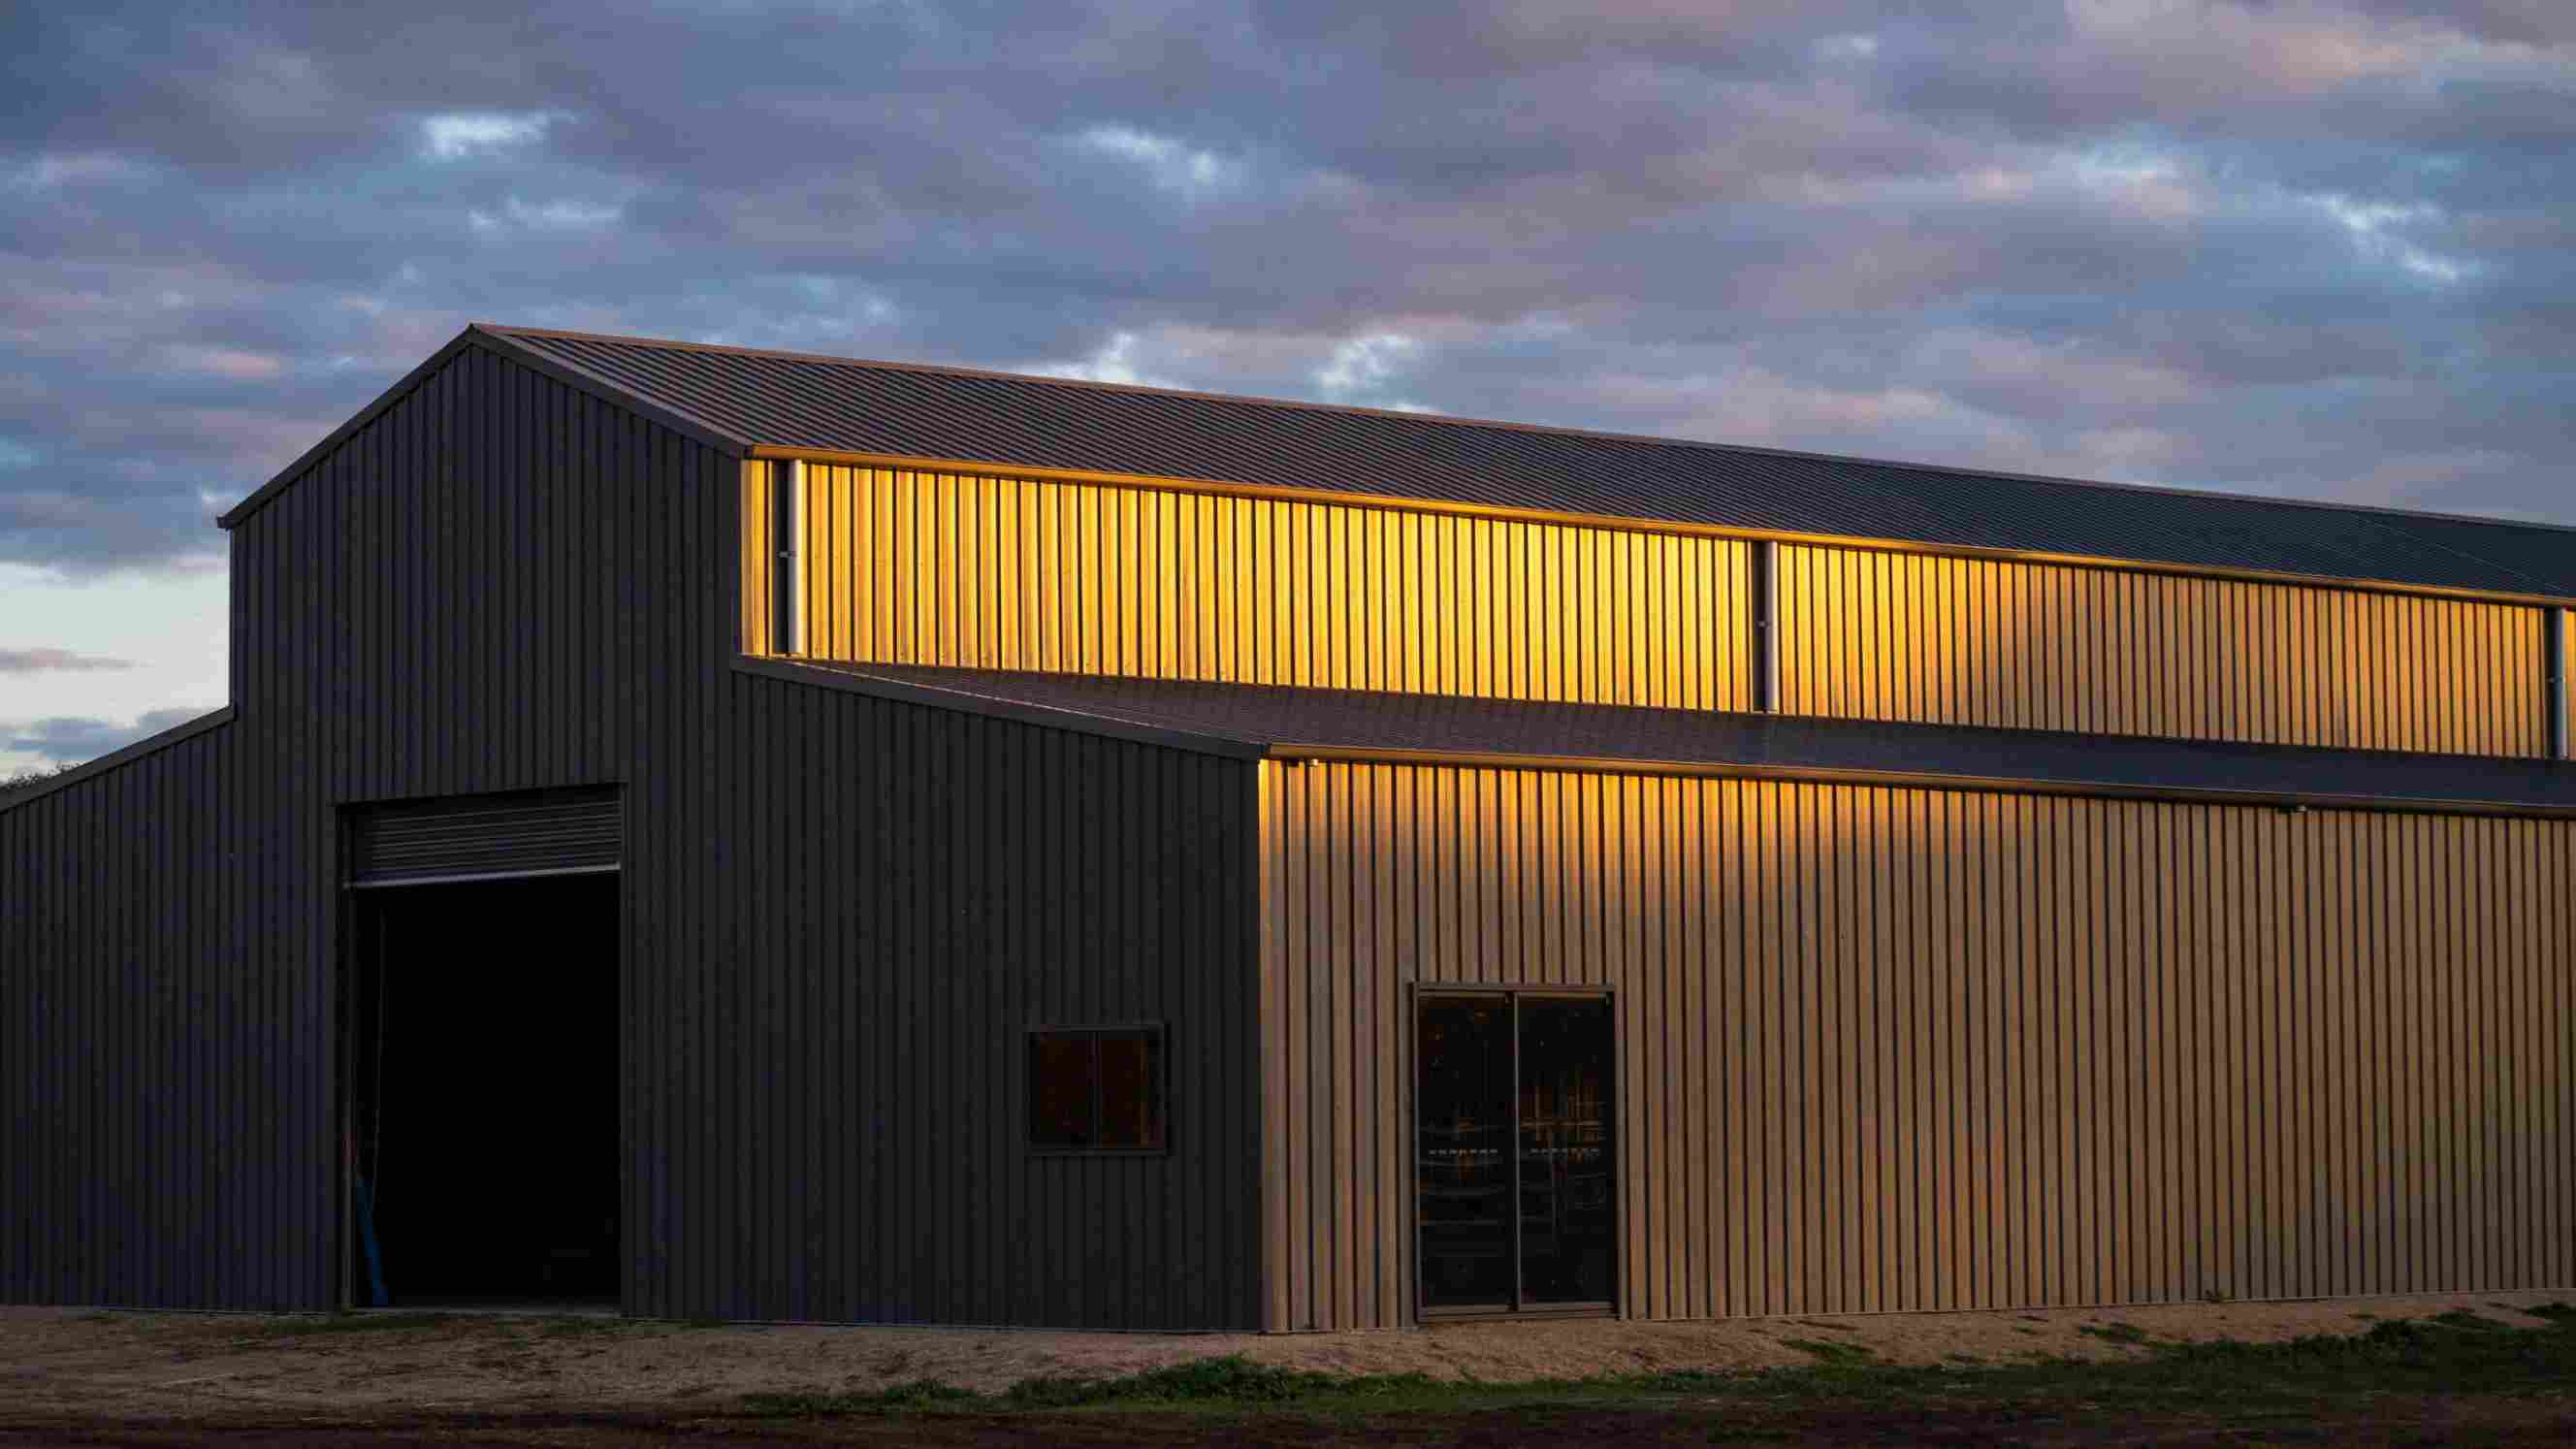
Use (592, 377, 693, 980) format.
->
(342, 874, 621, 1307)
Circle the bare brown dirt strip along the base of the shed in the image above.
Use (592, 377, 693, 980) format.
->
(0, 1292, 2568, 1412)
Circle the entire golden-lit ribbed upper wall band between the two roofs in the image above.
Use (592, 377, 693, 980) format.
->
(745, 465, 2550, 756)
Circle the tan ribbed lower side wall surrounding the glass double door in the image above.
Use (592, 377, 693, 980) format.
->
(1260, 763, 2576, 1331)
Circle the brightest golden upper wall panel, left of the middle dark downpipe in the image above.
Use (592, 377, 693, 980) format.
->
(806, 467, 1749, 709)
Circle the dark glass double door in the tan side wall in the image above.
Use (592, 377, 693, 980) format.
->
(1414, 990, 1618, 1312)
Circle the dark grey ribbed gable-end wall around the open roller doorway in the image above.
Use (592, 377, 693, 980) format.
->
(0, 345, 1254, 1325)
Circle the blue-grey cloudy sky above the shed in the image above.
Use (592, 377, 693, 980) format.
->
(0, 0, 2576, 774)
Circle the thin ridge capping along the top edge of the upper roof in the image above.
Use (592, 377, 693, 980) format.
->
(484, 322, 2576, 541)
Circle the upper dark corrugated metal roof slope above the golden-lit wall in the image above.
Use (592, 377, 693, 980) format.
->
(479, 328, 2576, 598)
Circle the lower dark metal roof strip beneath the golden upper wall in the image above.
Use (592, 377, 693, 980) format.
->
(742, 660, 2576, 818)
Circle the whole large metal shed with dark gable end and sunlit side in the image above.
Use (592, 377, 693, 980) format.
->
(0, 328, 2576, 1331)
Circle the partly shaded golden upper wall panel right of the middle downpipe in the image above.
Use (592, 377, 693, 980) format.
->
(1780, 547, 2548, 756)
